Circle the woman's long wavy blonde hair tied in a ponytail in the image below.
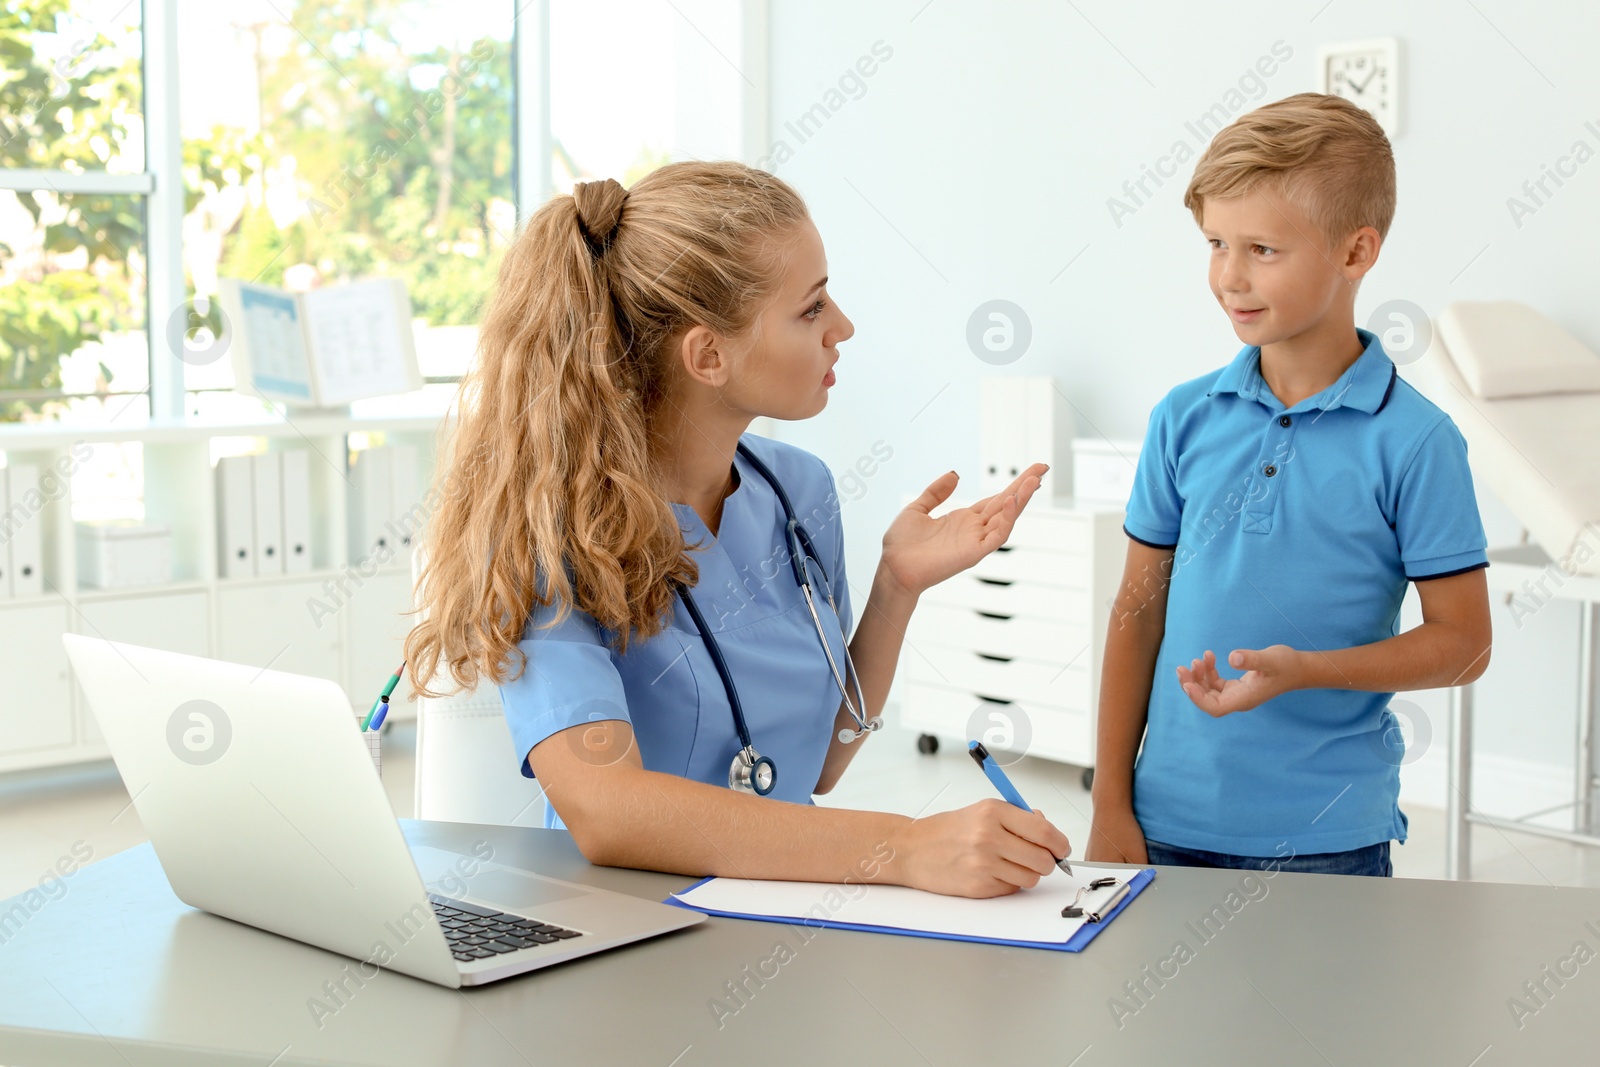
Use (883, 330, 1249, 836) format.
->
(405, 156, 808, 696)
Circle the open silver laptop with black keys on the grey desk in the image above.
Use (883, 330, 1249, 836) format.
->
(61, 633, 706, 989)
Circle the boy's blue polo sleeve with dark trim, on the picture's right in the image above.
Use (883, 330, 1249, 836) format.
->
(1395, 416, 1488, 582)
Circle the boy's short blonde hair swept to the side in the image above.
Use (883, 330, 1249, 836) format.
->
(1184, 93, 1395, 242)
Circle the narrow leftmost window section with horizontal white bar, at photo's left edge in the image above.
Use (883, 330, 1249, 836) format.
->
(0, 0, 149, 422)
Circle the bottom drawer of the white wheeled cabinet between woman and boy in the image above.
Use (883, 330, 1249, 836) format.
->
(901, 683, 1094, 767)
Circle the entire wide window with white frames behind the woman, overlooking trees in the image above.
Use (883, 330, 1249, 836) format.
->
(0, 0, 765, 424)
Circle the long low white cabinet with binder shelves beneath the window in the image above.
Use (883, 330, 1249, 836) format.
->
(0, 414, 440, 773)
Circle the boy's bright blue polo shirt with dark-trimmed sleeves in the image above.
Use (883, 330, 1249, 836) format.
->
(1125, 330, 1488, 856)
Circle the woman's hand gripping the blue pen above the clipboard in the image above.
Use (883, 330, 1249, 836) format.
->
(893, 800, 1072, 897)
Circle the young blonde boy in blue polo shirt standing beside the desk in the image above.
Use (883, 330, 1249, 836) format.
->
(1088, 93, 1490, 877)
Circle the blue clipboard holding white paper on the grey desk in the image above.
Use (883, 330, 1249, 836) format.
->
(664, 867, 1155, 952)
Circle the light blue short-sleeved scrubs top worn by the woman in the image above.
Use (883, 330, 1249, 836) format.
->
(499, 434, 850, 827)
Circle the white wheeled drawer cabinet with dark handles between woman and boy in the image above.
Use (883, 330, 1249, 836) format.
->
(901, 498, 1128, 780)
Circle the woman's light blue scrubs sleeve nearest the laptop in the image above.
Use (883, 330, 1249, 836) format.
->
(499, 605, 632, 777)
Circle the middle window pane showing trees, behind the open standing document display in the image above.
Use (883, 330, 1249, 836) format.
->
(178, 0, 517, 416)
